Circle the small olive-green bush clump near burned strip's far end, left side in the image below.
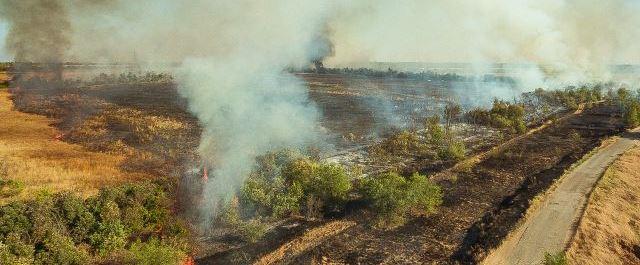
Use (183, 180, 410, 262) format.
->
(466, 99, 527, 134)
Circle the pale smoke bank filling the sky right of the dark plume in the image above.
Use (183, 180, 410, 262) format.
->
(329, 0, 640, 83)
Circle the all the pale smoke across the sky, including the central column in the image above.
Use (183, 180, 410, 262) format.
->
(0, 0, 640, 224)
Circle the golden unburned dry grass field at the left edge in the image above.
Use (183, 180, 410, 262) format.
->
(0, 87, 150, 202)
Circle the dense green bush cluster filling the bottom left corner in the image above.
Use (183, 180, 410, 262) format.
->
(0, 183, 187, 264)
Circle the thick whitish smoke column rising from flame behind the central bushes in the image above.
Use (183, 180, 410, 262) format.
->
(172, 1, 332, 221)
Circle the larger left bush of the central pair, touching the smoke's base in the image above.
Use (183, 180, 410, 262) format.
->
(240, 153, 351, 217)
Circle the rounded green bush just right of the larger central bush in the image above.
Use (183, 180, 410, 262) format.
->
(360, 172, 442, 227)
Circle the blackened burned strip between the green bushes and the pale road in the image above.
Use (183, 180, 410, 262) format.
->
(297, 102, 620, 264)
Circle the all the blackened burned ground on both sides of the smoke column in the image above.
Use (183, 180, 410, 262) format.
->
(2, 68, 622, 264)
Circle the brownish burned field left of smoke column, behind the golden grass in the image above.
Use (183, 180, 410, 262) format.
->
(11, 71, 199, 176)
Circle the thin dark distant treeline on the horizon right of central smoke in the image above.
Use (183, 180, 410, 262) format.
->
(301, 67, 516, 85)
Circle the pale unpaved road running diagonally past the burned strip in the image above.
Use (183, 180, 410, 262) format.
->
(483, 129, 639, 265)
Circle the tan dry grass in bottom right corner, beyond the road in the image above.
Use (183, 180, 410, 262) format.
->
(567, 147, 640, 265)
